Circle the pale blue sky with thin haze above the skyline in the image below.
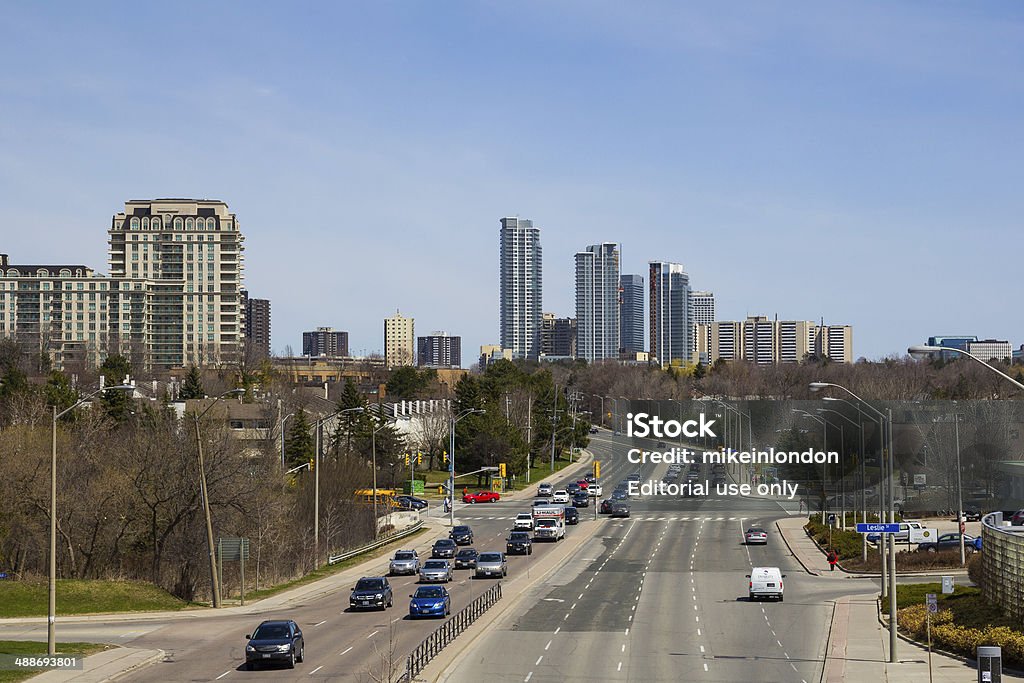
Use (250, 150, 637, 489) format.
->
(0, 0, 1024, 365)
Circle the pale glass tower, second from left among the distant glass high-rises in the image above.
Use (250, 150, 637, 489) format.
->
(575, 242, 620, 362)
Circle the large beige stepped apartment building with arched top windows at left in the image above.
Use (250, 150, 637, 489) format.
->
(2, 199, 245, 370)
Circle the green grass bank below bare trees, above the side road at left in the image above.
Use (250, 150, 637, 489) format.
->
(0, 579, 199, 617)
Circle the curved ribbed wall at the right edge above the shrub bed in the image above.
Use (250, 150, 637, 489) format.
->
(981, 512, 1024, 620)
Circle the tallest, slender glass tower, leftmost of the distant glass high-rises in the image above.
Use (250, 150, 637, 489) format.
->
(499, 218, 543, 358)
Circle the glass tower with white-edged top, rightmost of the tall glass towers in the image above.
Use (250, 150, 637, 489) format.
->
(648, 261, 694, 368)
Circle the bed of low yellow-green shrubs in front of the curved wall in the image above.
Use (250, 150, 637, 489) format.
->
(883, 584, 1024, 668)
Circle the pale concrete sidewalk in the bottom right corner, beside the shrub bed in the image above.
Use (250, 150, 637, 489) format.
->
(821, 595, 1024, 683)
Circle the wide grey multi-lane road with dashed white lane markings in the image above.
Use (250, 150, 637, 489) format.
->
(0, 433, 870, 683)
